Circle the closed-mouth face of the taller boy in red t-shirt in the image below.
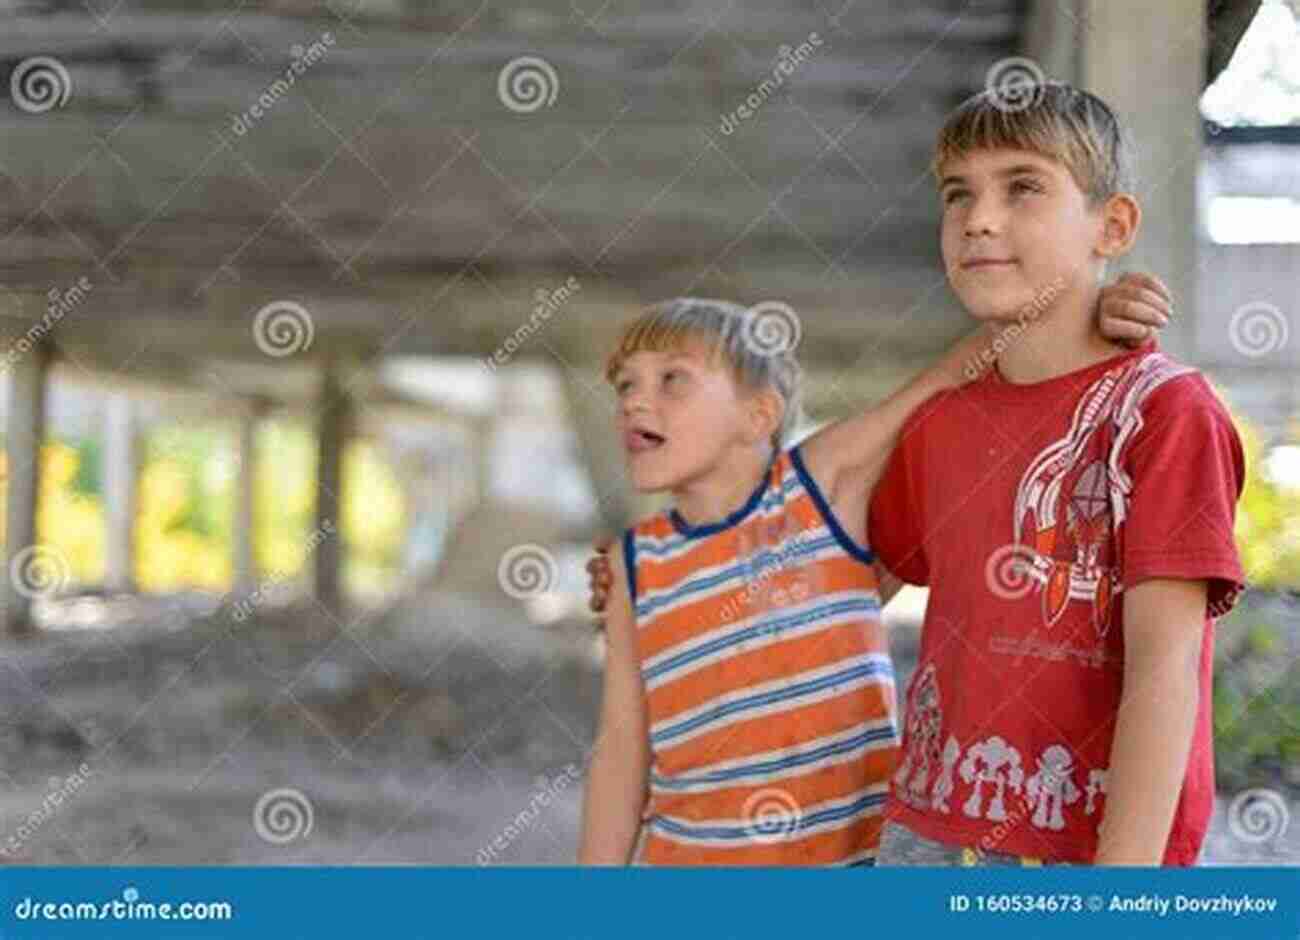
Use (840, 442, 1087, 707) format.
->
(940, 150, 1104, 321)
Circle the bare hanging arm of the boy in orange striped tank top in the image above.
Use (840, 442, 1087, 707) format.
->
(577, 541, 650, 865)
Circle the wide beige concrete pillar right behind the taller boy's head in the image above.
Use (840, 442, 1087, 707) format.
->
(1071, 0, 1206, 363)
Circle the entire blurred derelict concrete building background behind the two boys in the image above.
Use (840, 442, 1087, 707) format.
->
(0, 0, 1300, 865)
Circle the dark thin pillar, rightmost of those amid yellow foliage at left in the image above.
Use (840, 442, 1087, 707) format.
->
(311, 360, 352, 612)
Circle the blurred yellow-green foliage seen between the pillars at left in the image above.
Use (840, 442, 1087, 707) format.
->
(0, 421, 406, 592)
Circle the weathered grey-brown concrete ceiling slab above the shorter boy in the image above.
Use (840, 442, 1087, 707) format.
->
(0, 0, 1021, 397)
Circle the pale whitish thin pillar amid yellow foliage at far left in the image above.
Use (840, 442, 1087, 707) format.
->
(103, 393, 139, 592)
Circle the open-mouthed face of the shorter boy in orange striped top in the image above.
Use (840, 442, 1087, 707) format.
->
(614, 341, 750, 493)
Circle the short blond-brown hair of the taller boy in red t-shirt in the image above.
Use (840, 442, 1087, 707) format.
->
(931, 82, 1134, 205)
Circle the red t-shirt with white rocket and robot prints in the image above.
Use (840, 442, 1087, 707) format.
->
(868, 343, 1244, 865)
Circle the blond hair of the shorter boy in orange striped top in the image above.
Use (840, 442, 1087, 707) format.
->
(605, 296, 803, 450)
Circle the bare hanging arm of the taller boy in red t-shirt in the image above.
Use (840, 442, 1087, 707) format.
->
(1096, 579, 1208, 865)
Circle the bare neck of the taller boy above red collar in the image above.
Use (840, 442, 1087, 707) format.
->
(992, 285, 1125, 385)
